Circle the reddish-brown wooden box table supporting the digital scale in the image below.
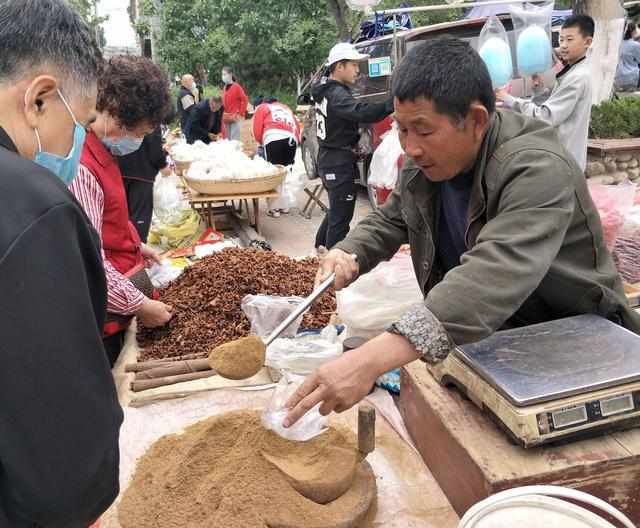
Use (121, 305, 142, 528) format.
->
(398, 361, 640, 523)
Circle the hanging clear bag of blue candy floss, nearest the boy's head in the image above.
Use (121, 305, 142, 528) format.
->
(509, 2, 553, 77)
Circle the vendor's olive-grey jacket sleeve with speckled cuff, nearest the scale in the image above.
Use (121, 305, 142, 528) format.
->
(392, 149, 575, 362)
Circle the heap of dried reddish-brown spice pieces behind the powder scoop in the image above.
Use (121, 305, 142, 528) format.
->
(138, 249, 336, 361)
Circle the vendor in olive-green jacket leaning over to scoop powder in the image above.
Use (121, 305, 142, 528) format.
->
(285, 39, 640, 426)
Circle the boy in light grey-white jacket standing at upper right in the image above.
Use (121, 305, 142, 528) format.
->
(496, 15, 595, 170)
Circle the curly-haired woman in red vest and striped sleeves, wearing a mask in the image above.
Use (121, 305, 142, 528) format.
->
(69, 55, 171, 365)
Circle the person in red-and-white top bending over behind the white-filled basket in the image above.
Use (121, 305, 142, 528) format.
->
(252, 98, 300, 218)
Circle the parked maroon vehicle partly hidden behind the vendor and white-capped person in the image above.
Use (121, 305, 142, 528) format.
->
(298, 15, 557, 207)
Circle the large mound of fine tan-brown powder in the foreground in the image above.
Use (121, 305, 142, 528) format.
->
(118, 411, 376, 528)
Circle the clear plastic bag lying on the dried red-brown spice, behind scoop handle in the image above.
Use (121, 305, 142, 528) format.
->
(240, 295, 304, 337)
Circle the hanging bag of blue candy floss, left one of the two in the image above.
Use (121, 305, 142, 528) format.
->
(478, 16, 513, 89)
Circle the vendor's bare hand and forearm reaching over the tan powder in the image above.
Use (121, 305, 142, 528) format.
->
(284, 332, 420, 427)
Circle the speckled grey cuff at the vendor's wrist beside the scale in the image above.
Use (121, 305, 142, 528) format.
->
(387, 303, 454, 363)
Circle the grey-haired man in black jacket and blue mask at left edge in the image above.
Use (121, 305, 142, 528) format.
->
(0, 0, 122, 528)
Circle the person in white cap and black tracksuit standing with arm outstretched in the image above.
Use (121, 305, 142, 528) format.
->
(312, 42, 393, 249)
